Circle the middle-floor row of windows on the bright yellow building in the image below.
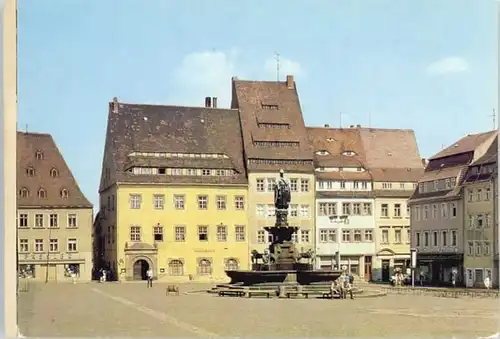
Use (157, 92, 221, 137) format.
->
(130, 225, 246, 242)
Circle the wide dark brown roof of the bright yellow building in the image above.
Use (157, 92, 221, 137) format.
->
(107, 102, 247, 184)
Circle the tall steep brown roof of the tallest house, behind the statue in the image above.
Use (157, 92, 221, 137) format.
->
(231, 76, 313, 173)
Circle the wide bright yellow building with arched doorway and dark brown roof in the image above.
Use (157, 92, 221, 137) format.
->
(97, 98, 250, 281)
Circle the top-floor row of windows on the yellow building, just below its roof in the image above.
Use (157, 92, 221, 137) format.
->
(127, 194, 245, 211)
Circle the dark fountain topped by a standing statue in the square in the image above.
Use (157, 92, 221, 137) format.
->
(226, 170, 342, 286)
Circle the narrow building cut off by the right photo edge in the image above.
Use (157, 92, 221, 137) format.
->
(463, 139, 498, 287)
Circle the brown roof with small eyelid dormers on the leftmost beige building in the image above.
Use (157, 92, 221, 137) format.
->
(17, 132, 92, 208)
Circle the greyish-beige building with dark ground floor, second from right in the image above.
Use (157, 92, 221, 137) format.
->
(410, 132, 496, 285)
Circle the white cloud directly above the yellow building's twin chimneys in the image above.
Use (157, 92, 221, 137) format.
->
(169, 49, 238, 107)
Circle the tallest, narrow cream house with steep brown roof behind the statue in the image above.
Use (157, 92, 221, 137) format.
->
(231, 75, 315, 252)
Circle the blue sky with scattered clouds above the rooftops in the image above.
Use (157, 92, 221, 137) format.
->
(18, 0, 497, 207)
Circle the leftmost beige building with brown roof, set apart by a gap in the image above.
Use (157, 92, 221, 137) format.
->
(17, 132, 93, 282)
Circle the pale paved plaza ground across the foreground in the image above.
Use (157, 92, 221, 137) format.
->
(19, 283, 499, 338)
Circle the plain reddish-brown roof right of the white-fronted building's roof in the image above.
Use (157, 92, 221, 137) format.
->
(360, 128, 423, 169)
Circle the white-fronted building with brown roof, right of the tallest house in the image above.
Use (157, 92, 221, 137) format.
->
(307, 126, 375, 280)
